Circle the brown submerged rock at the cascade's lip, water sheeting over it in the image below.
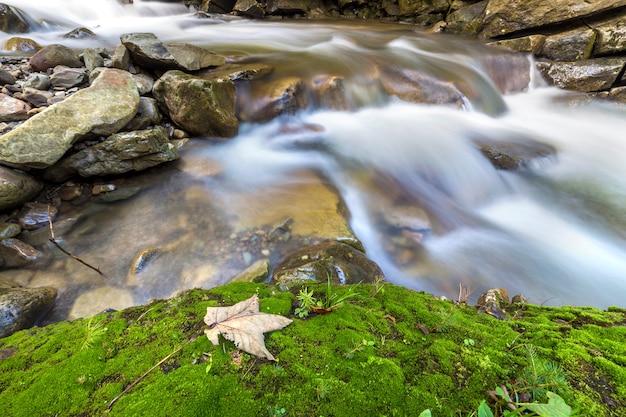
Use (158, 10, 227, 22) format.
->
(380, 67, 463, 107)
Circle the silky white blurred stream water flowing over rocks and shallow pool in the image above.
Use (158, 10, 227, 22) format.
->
(0, 0, 626, 320)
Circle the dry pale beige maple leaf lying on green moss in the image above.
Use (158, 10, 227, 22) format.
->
(204, 294, 291, 361)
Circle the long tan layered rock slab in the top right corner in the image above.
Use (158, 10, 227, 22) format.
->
(476, 0, 626, 38)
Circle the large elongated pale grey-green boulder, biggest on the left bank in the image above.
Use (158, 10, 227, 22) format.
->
(0, 69, 139, 168)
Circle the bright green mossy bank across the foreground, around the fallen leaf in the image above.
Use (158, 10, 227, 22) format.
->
(0, 283, 626, 417)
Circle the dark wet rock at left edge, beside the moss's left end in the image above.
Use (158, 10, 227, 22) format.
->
(0, 281, 57, 338)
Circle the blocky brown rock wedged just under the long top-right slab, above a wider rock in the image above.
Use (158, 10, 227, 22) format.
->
(539, 29, 596, 61)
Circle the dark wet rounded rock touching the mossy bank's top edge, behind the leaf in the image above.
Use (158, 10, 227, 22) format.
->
(272, 241, 384, 285)
